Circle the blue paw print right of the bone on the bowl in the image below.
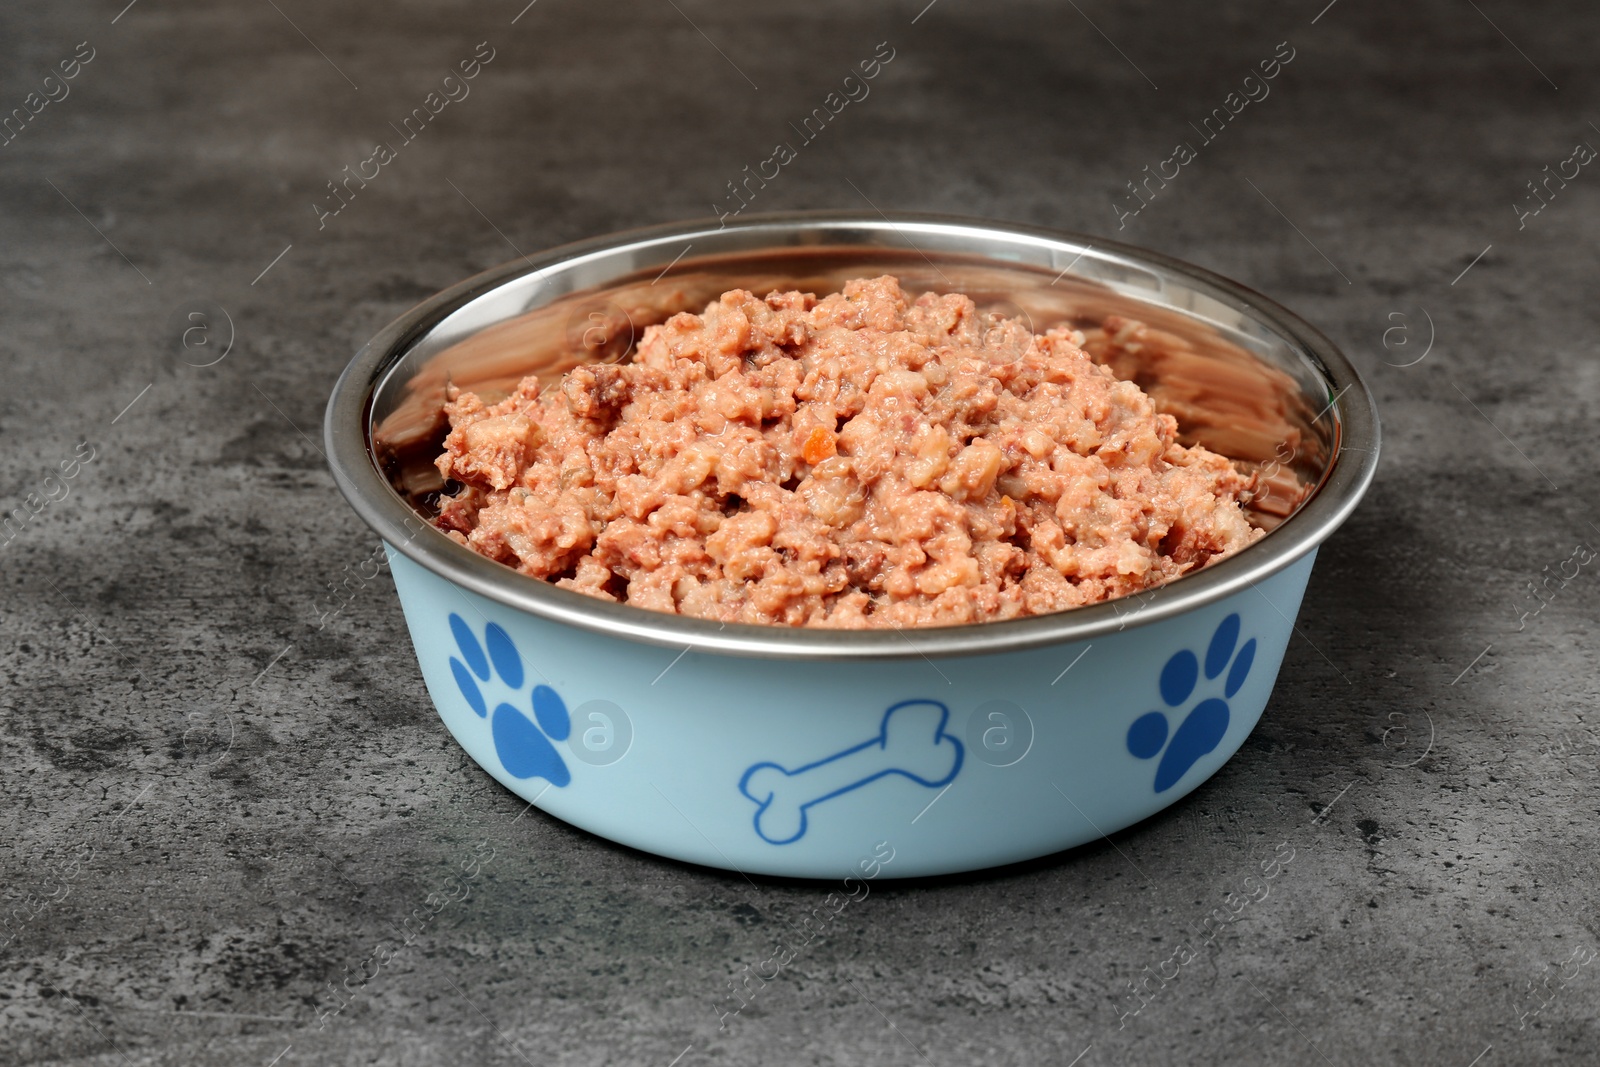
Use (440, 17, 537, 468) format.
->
(1128, 614, 1256, 793)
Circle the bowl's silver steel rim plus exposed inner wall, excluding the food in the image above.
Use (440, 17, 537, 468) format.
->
(326, 214, 1378, 657)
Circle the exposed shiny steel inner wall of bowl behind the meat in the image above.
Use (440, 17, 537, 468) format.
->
(371, 225, 1339, 528)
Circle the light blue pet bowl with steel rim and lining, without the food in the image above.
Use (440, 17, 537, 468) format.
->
(326, 214, 1378, 878)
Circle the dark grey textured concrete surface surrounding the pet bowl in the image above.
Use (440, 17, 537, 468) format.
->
(0, 0, 1600, 1067)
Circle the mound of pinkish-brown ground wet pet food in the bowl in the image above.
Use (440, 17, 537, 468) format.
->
(438, 277, 1261, 627)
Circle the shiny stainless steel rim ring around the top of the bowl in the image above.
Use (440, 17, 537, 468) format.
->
(323, 213, 1379, 659)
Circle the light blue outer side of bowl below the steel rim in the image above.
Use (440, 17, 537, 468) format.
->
(389, 547, 1315, 878)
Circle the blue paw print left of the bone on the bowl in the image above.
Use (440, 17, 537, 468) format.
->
(450, 613, 573, 785)
